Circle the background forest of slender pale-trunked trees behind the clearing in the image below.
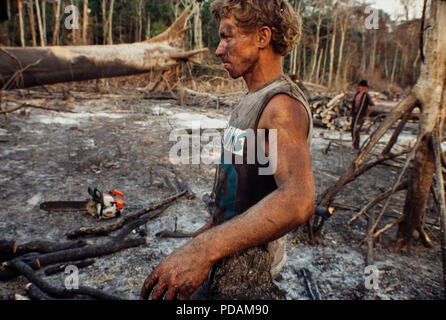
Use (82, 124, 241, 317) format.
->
(0, 0, 421, 90)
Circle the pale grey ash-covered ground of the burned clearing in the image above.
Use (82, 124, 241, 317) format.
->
(0, 85, 443, 300)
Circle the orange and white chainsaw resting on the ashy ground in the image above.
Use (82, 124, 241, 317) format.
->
(40, 188, 124, 220)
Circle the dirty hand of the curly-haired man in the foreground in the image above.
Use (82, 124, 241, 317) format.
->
(141, 240, 212, 300)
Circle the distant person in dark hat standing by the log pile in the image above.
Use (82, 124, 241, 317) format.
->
(349, 80, 375, 150)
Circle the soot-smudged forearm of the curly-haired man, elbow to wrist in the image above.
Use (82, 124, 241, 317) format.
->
(187, 188, 314, 263)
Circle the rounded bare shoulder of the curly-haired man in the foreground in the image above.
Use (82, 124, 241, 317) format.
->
(258, 93, 309, 136)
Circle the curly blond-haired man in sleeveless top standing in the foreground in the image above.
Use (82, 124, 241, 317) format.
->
(141, 0, 314, 299)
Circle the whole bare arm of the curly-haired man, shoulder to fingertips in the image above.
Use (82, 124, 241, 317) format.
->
(141, 95, 314, 299)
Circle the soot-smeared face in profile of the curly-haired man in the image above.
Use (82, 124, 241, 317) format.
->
(215, 17, 259, 79)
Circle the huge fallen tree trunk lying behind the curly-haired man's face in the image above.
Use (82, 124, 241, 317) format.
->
(0, 9, 207, 89)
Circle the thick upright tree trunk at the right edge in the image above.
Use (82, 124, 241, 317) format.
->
(396, 0, 446, 251)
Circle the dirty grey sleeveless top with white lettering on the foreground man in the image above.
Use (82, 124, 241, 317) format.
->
(213, 75, 313, 225)
